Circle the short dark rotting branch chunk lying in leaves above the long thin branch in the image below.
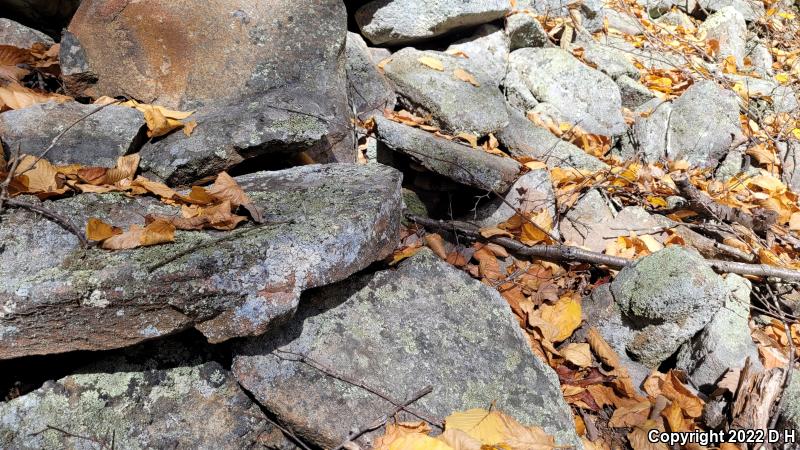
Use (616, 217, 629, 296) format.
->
(674, 176, 778, 234)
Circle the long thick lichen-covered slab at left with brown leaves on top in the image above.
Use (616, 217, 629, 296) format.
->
(0, 164, 401, 359)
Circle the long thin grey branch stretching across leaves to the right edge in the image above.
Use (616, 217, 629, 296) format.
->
(407, 215, 800, 281)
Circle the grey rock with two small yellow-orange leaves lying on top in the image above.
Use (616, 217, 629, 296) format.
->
(383, 47, 508, 136)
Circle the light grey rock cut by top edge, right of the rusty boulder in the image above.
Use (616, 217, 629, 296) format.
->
(355, 0, 510, 45)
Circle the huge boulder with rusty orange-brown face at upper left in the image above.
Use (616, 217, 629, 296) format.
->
(61, 0, 355, 172)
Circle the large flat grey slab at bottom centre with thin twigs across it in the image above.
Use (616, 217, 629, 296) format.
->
(233, 250, 579, 448)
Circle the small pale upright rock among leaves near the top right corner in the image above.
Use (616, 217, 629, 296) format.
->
(700, 6, 747, 67)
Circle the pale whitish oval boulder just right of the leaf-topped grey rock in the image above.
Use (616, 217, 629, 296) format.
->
(509, 48, 626, 136)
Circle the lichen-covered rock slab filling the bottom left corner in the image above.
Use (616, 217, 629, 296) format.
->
(0, 362, 269, 450)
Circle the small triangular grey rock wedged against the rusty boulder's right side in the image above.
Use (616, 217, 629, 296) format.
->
(345, 32, 397, 120)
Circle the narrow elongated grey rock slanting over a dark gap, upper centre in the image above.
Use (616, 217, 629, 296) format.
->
(375, 116, 521, 193)
